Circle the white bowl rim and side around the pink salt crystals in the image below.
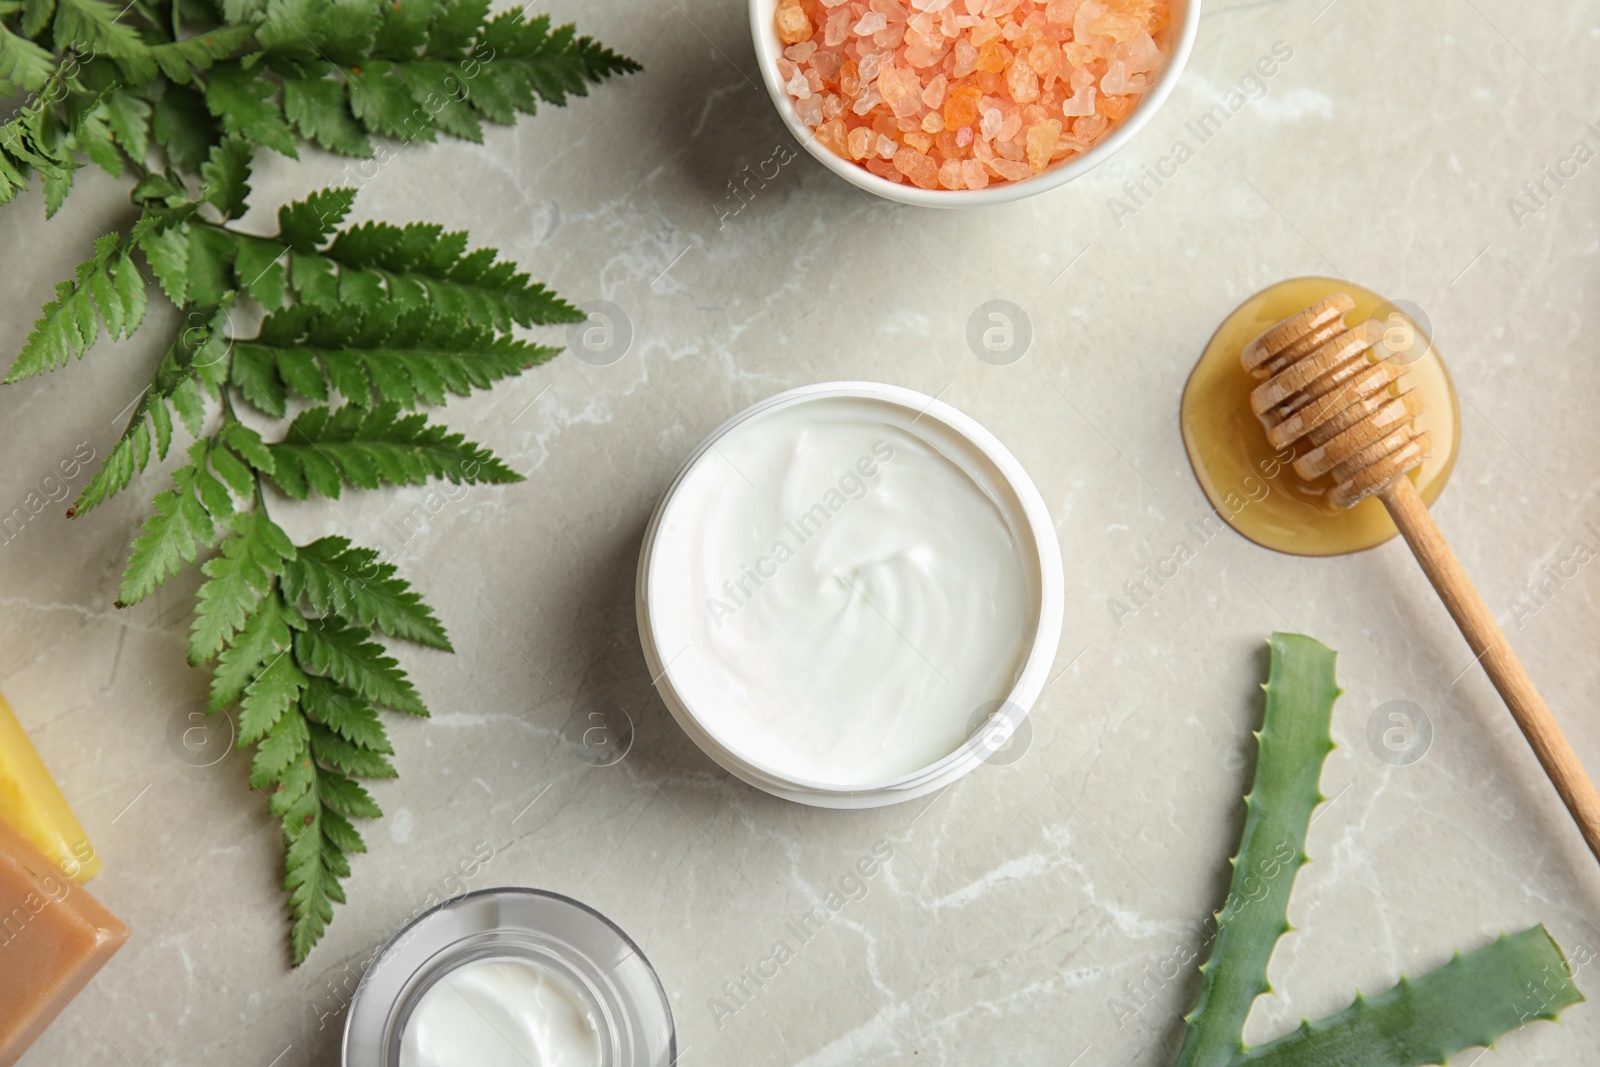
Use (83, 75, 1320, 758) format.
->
(750, 0, 1200, 208)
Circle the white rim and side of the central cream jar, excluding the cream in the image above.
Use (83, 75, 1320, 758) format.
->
(635, 382, 1062, 808)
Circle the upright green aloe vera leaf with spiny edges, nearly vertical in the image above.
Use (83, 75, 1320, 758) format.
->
(1176, 633, 1341, 1067)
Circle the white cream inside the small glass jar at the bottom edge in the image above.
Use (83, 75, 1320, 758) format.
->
(400, 960, 602, 1067)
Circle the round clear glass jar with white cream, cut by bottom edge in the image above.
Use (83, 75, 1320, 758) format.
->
(342, 888, 677, 1067)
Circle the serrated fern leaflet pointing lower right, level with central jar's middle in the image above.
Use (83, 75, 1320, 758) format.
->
(283, 537, 454, 646)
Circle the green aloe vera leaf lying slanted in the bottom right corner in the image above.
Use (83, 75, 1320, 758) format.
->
(1234, 926, 1584, 1067)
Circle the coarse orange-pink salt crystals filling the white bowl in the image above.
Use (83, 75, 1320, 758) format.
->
(774, 0, 1171, 190)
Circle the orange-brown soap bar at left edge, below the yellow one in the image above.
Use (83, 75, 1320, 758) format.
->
(0, 819, 128, 1067)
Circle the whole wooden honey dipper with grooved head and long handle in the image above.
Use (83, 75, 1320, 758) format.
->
(1240, 293, 1600, 859)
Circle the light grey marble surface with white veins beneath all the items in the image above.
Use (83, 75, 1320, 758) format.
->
(0, 0, 1600, 1067)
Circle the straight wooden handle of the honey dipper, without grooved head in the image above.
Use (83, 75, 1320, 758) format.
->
(1382, 477, 1600, 859)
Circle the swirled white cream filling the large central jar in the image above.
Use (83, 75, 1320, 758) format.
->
(651, 397, 1038, 787)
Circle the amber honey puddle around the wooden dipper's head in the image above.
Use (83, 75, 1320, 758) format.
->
(1181, 278, 1461, 555)
